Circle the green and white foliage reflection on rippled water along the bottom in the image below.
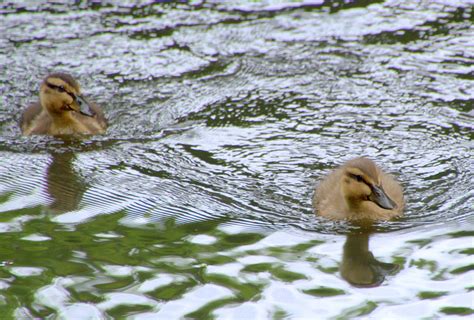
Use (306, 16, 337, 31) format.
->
(1, 199, 472, 318)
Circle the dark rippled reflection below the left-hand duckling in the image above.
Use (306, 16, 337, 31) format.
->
(46, 152, 87, 214)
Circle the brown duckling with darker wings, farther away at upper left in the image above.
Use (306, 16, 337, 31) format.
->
(20, 73, 107, 136)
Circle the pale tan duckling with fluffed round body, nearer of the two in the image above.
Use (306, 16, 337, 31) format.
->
(313, 157, 404, 221)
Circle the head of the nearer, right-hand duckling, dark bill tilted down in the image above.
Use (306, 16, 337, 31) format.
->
(341, 158, 397, 210)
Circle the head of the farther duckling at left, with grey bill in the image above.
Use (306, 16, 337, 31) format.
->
(40, 73, 95, 117)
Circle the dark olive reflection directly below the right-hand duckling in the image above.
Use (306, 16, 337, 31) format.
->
(339, 233, 400, 287)
